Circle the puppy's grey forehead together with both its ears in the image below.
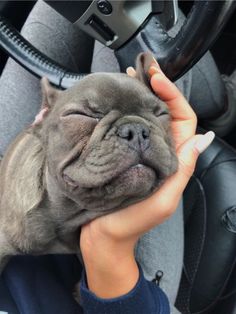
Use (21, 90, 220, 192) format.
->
(39, 53, 167, 116)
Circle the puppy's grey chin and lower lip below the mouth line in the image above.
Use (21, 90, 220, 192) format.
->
(63, 164, 160, 211)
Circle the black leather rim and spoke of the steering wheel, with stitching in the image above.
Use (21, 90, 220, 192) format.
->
(0, 0, 236, 88)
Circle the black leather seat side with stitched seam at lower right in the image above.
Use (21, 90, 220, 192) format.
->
(177, 139, 236, 314)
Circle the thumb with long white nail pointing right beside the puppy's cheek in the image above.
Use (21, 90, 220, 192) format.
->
(177, 131, 215, 180)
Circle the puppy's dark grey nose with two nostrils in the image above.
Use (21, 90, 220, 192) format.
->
(117, 123, 150, 151)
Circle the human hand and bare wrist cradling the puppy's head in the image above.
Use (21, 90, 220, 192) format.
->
(80, 62, 214, 298)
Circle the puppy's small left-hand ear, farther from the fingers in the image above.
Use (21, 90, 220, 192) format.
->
(41, 77, 61, 109)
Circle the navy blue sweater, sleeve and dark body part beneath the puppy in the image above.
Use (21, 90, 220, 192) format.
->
(0, 255, 170, 314)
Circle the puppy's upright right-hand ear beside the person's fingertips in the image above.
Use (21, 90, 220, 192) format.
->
(135, 52, 154, 89)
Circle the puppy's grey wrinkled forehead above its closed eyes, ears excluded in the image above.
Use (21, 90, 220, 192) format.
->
(55, 73, 160, 114)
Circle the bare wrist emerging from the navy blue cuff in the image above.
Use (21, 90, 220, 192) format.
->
(80, 226, 139, 298)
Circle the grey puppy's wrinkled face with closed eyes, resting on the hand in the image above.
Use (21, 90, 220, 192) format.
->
(37, 52, 177, 211)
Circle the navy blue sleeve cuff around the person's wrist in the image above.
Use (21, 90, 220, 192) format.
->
(80, 267, 170, 314)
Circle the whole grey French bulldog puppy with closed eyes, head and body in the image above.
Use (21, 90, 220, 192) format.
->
(0, 53, 177, 269)
